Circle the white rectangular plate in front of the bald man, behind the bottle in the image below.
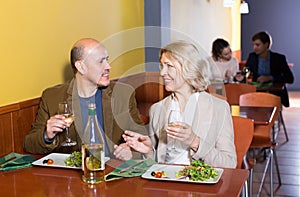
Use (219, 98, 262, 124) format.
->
(32, 153, 110, 169)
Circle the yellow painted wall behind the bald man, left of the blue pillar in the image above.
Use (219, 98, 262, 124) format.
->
(0, 0, 144, 106)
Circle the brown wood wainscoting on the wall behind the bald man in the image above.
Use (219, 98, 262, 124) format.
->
(0, 72, 168, 156)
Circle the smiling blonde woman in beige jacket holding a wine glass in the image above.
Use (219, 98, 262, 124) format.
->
(123, 41, 236, 168)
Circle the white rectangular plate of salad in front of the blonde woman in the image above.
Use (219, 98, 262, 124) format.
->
(142, 164, 223, 184)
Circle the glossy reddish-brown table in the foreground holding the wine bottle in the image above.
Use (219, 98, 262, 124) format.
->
(0, 160, 249, 197)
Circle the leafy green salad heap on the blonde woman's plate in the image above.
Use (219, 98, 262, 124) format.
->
(176, 160, 218, 181)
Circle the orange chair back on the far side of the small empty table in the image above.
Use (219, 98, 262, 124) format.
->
(224, 83, 256, 105)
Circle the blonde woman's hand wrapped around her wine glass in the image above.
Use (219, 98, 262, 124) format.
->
(167, 122, 199, 148)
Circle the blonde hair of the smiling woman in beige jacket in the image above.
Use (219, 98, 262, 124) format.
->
(159, 41, 209, 92)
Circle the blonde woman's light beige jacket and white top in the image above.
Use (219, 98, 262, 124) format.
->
(149, 91, 236, 168)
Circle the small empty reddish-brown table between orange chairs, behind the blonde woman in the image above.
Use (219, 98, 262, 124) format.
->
(240, 106, 276, 125)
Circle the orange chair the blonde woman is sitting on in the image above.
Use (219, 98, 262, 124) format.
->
(232, 116, 255, 196)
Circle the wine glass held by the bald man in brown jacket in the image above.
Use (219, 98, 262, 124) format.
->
(58, 102, 77, 146)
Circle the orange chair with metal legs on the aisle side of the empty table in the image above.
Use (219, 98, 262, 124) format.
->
(239, 92, 281, 196)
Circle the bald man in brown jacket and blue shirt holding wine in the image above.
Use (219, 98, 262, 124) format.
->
(23, 38, 147, 160)
